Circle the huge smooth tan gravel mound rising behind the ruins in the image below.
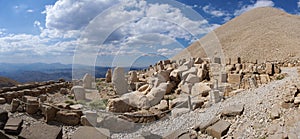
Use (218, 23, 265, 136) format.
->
(173, 7, 300, 61)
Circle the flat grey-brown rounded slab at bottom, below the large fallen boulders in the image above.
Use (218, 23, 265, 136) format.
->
(99, 116, 135, 132)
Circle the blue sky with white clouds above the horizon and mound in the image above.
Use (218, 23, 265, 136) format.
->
(0, 0, 300, 66)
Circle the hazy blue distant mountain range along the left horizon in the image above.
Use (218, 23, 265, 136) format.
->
(0, 63, 143, 83)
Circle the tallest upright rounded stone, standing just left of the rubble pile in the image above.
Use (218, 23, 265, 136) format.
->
(112, 67, 128, 95)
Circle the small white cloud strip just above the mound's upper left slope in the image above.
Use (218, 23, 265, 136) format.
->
(234, 0, 275, 16)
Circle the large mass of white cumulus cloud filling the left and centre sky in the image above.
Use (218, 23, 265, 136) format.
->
(0, 0, 223, 64)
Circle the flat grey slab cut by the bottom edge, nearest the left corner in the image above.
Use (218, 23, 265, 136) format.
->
(19, 123, 63, 139)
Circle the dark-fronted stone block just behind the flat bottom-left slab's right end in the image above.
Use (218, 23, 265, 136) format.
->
(55, 111, 80, 126)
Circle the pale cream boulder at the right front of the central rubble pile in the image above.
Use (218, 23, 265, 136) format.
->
(191, 83, 211, 97)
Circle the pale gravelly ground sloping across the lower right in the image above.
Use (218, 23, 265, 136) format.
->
(112, 68, 300, 138)
